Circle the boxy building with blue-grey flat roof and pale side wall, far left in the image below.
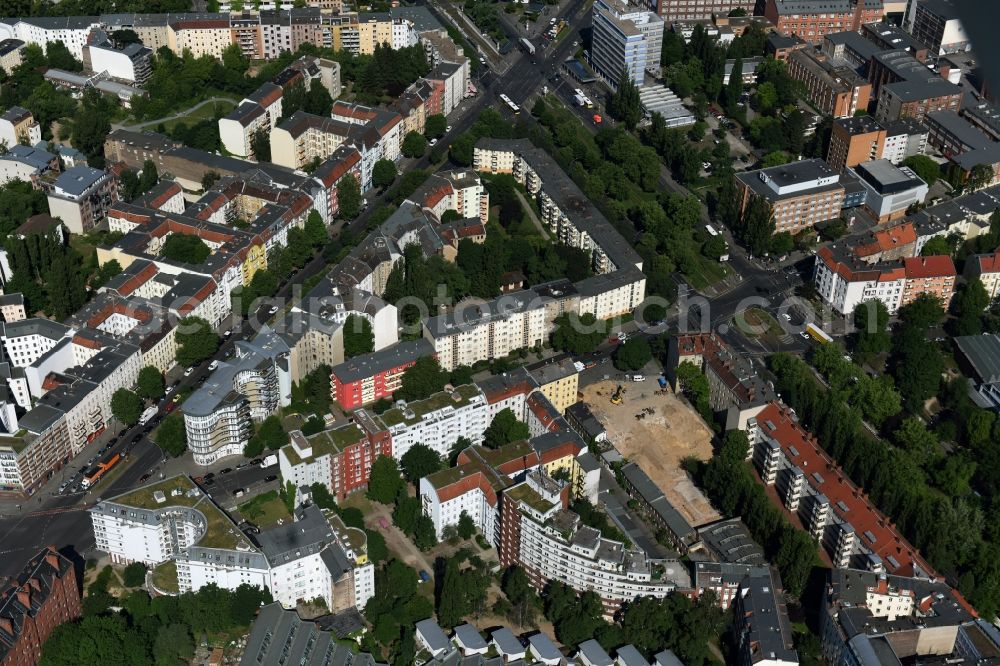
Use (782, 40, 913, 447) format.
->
(47, 165, 118, 234)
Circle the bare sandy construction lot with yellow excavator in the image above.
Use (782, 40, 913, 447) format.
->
(583, 378, 722, 527)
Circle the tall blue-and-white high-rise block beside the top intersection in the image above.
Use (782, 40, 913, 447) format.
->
(590, 0, 663, 88)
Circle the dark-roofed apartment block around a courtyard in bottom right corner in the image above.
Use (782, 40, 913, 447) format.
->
(820, 568, 984, 666)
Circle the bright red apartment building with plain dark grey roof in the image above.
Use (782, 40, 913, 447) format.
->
(330, 338, 434, 410)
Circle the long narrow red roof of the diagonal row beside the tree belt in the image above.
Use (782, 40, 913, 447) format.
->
(757, 402, 936, 577)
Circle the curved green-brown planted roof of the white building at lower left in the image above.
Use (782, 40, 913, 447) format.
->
(107, 475, 251, 550)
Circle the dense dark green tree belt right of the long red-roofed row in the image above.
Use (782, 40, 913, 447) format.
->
(771, 348, 1000, 615)
